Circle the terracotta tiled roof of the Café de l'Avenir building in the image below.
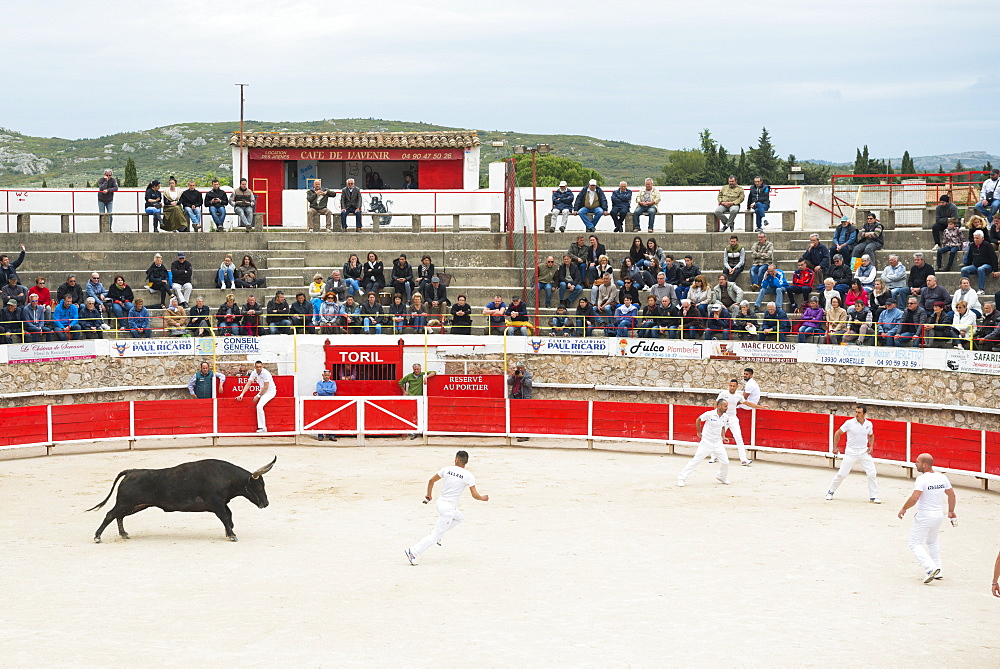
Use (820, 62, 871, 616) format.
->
(229, 131, 480, 149)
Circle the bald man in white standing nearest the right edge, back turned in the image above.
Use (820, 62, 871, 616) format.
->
(899, 453, 952, 588)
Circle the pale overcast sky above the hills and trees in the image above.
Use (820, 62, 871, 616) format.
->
(0, 0, 1000, 161)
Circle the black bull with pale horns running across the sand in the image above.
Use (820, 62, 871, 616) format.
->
(87, 456, 278, 543)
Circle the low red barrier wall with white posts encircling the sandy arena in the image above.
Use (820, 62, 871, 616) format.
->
(0, 396, 1000, 480)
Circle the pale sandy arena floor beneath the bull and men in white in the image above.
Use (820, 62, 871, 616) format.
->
(0, 440, 1000, 667)
